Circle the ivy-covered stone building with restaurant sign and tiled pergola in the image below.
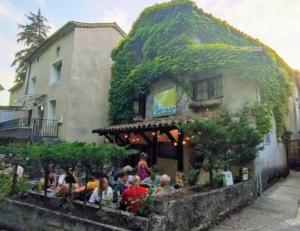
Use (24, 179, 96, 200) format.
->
(93, 0, 300, 189)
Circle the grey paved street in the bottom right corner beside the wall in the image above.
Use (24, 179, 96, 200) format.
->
(211, 171, 300, 231)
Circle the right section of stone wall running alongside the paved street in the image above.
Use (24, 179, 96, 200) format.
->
(155, 181, 256, 231)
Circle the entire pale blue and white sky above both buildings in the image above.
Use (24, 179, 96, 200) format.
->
(0, 0, 300, 105)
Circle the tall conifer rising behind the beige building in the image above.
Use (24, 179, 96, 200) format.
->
(12, 9, 51, 83)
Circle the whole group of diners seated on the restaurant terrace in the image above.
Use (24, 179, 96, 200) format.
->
(34, 153, 186, 213)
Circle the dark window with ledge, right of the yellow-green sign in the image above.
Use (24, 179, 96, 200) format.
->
(193, 77, 223, 100)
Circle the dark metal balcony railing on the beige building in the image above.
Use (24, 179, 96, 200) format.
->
(0, 118, 58, 137)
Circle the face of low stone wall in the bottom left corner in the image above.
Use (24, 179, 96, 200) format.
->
(0, 198, 126, 231)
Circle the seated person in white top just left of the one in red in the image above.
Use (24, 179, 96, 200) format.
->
(89, 177, 113, 205)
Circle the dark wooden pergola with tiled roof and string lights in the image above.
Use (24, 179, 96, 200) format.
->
(93, 118, 190, 171)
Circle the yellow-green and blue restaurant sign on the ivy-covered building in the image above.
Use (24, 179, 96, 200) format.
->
(153, 86, 176, 117)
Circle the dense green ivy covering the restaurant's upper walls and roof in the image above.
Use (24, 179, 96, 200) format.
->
(109, 0, 293, 135)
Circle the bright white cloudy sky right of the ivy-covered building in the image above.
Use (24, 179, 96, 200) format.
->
(196, 0, 300, 69)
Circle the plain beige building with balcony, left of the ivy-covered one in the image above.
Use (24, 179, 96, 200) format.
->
(0, 21, 125, 142)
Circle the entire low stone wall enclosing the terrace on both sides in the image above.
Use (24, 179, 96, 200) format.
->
(0, 181, 256, 231)
